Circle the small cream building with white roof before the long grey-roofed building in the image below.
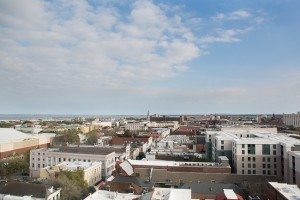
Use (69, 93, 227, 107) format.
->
(39, 161, 101, 186)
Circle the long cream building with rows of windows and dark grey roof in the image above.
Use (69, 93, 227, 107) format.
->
(29, 146, 115, 179)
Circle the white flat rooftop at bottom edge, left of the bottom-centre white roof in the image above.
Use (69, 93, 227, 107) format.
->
(84, 190, 140, 200)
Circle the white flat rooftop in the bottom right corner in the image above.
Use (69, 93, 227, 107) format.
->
(269, 182, 300, 200)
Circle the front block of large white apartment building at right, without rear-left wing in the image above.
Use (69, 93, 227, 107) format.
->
(232, 134, 300, 183)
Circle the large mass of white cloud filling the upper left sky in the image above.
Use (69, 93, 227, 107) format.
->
(0, 0, 201, 88)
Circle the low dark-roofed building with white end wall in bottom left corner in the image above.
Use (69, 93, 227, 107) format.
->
(0, 182, 61, 200)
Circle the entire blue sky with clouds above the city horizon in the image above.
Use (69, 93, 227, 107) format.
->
(0, 0, 300, 115)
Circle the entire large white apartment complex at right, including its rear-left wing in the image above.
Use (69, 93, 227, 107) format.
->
(206, 128, 300, 184)
